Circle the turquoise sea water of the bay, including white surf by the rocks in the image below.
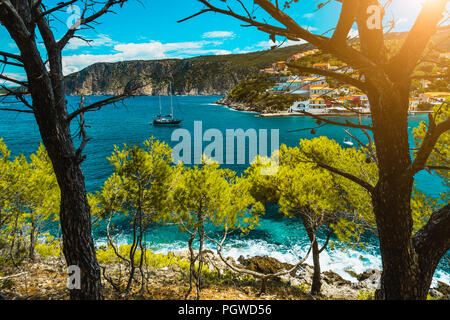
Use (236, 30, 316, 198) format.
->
(0, 96, 450, 283)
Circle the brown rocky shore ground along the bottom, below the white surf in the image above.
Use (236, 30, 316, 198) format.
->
(0, 250, 450, 300)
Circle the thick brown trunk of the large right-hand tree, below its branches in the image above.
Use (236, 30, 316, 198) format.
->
(371, 90, 424, 300)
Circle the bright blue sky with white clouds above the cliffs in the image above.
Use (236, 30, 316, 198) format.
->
(0, 0, 446, 79)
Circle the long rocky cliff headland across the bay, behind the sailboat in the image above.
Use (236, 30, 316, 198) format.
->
(66, 44, 312, 95)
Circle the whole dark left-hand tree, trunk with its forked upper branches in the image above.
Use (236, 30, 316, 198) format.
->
(0, 0, 134, 300)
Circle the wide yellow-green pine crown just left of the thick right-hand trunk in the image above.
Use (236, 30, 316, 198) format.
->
(247, 137, 378, 248)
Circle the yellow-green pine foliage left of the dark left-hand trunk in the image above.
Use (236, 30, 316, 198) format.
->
(0, 140, 60, 263)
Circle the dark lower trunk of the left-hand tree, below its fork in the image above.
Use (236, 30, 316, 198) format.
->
(31, 94, 103, 300)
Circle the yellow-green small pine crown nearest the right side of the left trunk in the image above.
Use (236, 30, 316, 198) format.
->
(89, 138, 172, 225)
